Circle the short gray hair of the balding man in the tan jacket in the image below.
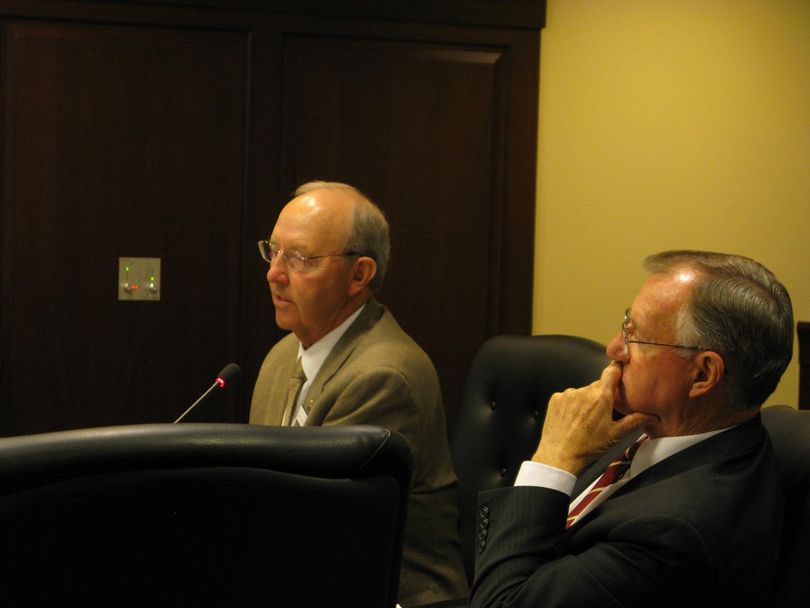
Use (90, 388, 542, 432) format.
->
(295, 181, 391, 293)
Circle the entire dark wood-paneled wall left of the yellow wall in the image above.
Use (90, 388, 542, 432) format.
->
(0, 0, 544, 435)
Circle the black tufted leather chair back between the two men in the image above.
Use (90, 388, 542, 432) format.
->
(450, 335, 609, 581)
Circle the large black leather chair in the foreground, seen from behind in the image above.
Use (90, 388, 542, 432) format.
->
(0, 424, 411, 608)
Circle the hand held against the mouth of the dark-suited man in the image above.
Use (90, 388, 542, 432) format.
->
(532, 361, 654, 475)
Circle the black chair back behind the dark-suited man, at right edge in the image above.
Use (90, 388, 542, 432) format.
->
(762, 405, 810, 608)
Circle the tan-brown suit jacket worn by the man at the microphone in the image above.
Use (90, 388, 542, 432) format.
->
(250, 300, 467, 608)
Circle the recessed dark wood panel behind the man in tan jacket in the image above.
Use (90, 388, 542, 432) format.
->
(278, 36, 505, 422)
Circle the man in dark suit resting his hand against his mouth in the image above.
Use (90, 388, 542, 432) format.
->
(471, 251, 793, 608)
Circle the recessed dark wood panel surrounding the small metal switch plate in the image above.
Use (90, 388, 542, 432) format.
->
(2, 22, 247, 434)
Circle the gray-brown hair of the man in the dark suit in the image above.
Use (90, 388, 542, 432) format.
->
(644, 250, 793, 409)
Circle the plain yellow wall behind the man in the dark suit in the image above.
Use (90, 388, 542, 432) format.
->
(533, 0, 810, 405)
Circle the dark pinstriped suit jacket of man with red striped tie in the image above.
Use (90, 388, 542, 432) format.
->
(471, 416, 782, 608)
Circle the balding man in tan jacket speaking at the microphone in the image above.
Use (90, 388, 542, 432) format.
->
(250, 182, 467, 608)
